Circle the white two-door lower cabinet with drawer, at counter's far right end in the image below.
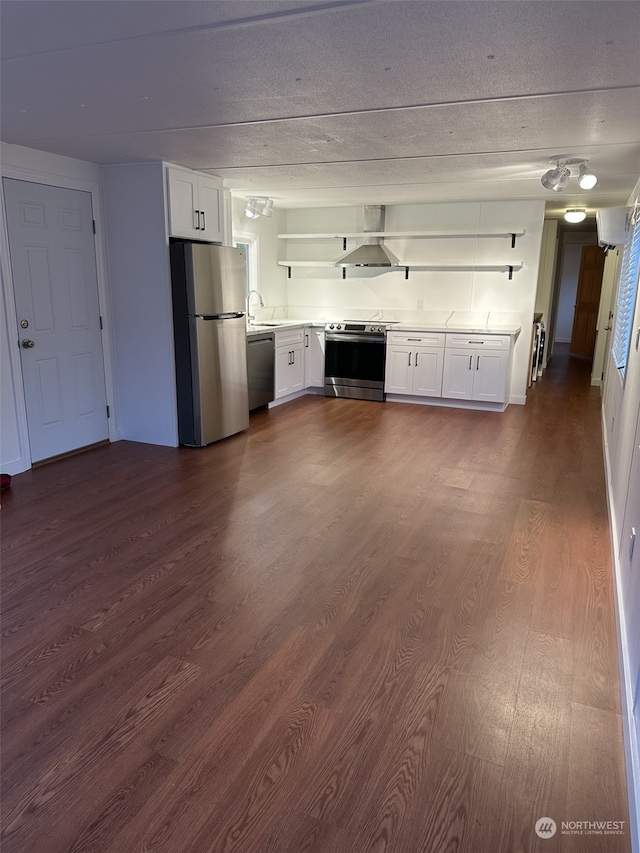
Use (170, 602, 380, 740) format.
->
(442, 334, 511, 403)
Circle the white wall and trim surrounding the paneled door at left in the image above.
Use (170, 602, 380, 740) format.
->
(0, 142, 118, 474)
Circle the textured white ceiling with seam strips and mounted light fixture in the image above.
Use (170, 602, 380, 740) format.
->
(0, 0, 640, 214)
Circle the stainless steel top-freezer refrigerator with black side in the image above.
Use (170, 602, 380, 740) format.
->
(170, 242, 249, 447)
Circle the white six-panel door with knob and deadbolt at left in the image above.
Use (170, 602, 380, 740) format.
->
(3, 178, 109, 462)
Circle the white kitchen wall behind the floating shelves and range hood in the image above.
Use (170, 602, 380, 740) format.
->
(280, 201, 544, 403)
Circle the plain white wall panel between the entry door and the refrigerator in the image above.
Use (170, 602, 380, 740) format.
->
(103, 161, 178, 447)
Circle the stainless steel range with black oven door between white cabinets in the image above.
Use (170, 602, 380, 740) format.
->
(324, 320, 387, 402)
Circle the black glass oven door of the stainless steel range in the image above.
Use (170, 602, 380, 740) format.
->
(324, 332, 386, 396)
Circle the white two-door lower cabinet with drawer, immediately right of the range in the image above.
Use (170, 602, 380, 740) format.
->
(384, 332, 445, 397)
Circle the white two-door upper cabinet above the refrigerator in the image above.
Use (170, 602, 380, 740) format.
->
(167, 166, 224, 243)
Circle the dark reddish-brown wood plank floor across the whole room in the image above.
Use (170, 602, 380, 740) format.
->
(1, 342, 630, 853)
